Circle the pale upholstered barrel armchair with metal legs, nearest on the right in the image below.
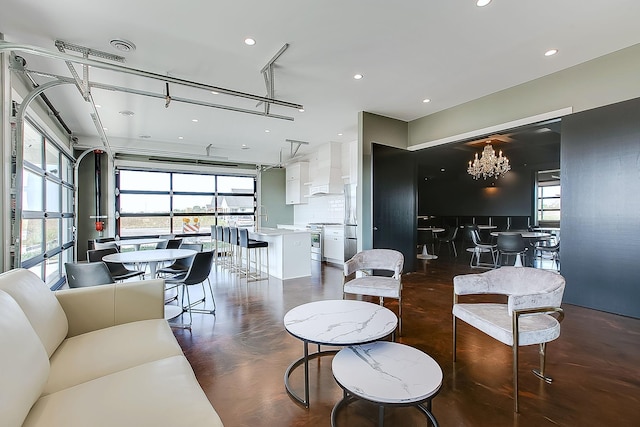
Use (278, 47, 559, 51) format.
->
(453, 267, 565, 412)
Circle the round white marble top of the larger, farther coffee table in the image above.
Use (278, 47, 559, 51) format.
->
(284, 300, 398, 345)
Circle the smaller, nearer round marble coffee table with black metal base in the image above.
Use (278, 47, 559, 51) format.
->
(331, 341, 442, 427)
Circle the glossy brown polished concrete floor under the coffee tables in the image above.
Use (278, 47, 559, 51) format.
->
(174, 252, 640, 427)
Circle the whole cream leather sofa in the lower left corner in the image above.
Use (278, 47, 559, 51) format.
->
(0, 269, 222, 427)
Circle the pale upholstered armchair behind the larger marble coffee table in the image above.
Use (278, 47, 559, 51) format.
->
(342, 249, 404, 335)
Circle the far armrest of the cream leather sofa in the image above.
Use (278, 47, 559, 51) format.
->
(55, 279, 164, 337)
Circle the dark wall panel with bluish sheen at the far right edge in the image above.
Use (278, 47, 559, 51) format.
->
(561, 99, 640, 317)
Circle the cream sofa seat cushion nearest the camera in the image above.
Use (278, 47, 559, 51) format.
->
(24, 356, 222, 427)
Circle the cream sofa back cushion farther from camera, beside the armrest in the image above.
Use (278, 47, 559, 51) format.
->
(0, 268, 68, 356)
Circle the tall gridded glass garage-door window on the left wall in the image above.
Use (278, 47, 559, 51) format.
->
(20, 120, 74, 287)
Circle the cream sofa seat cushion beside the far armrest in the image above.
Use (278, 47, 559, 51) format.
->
(43, 319, 182, 394)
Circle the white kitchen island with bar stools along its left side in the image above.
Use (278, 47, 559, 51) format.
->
(249, 228, 311, 280)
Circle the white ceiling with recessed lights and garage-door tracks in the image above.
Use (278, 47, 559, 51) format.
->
(0, 0, 640, 164)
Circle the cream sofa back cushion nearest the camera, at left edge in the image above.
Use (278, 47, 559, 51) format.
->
(0, 290, 49, 427)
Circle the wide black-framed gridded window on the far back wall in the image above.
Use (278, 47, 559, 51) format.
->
(116, 169, 256, 237)
